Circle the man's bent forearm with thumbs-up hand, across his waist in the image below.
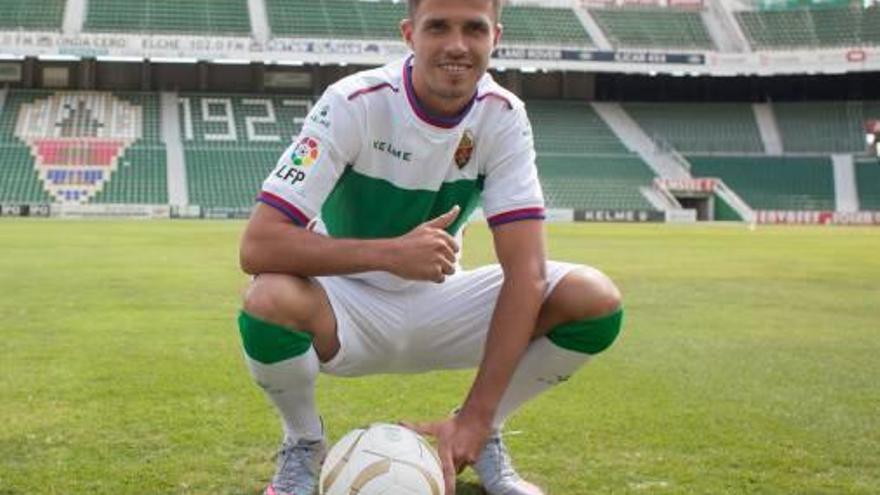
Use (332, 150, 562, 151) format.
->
(239, 203, 459, 282)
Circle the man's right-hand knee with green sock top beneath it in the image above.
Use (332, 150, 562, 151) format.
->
(547, 267, 623, 355)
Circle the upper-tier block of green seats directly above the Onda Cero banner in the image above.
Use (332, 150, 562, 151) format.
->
(85, 0, 251, 35)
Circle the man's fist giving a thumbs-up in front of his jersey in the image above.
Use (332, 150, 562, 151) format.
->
(388, 205, 461, 283)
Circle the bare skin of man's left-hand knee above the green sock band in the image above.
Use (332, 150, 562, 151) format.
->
(242, 274, 315, 329)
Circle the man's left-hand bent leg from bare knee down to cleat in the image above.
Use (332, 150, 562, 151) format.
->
(238, 274, 339, 495)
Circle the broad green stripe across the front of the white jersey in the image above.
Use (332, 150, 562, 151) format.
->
(321, 167, 483, 239)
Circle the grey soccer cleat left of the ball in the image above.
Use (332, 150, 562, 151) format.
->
(264, 439, 327, 495)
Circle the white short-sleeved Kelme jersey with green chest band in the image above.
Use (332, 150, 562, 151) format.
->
(258, 57, 544, 288)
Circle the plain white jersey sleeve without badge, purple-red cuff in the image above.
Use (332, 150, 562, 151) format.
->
(482, 106, 545, 227)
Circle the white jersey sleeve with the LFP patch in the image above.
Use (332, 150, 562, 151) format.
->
(257, 86, 363, 226)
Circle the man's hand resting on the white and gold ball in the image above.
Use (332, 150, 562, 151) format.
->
(403, 416, 490, 495)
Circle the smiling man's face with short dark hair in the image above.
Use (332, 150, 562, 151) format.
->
(401, 0, 501, 106)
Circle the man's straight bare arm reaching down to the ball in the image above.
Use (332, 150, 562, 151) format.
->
(408, 220, 546, 495)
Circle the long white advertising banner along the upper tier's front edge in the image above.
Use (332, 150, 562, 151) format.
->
(0, 31, 880, 76)
